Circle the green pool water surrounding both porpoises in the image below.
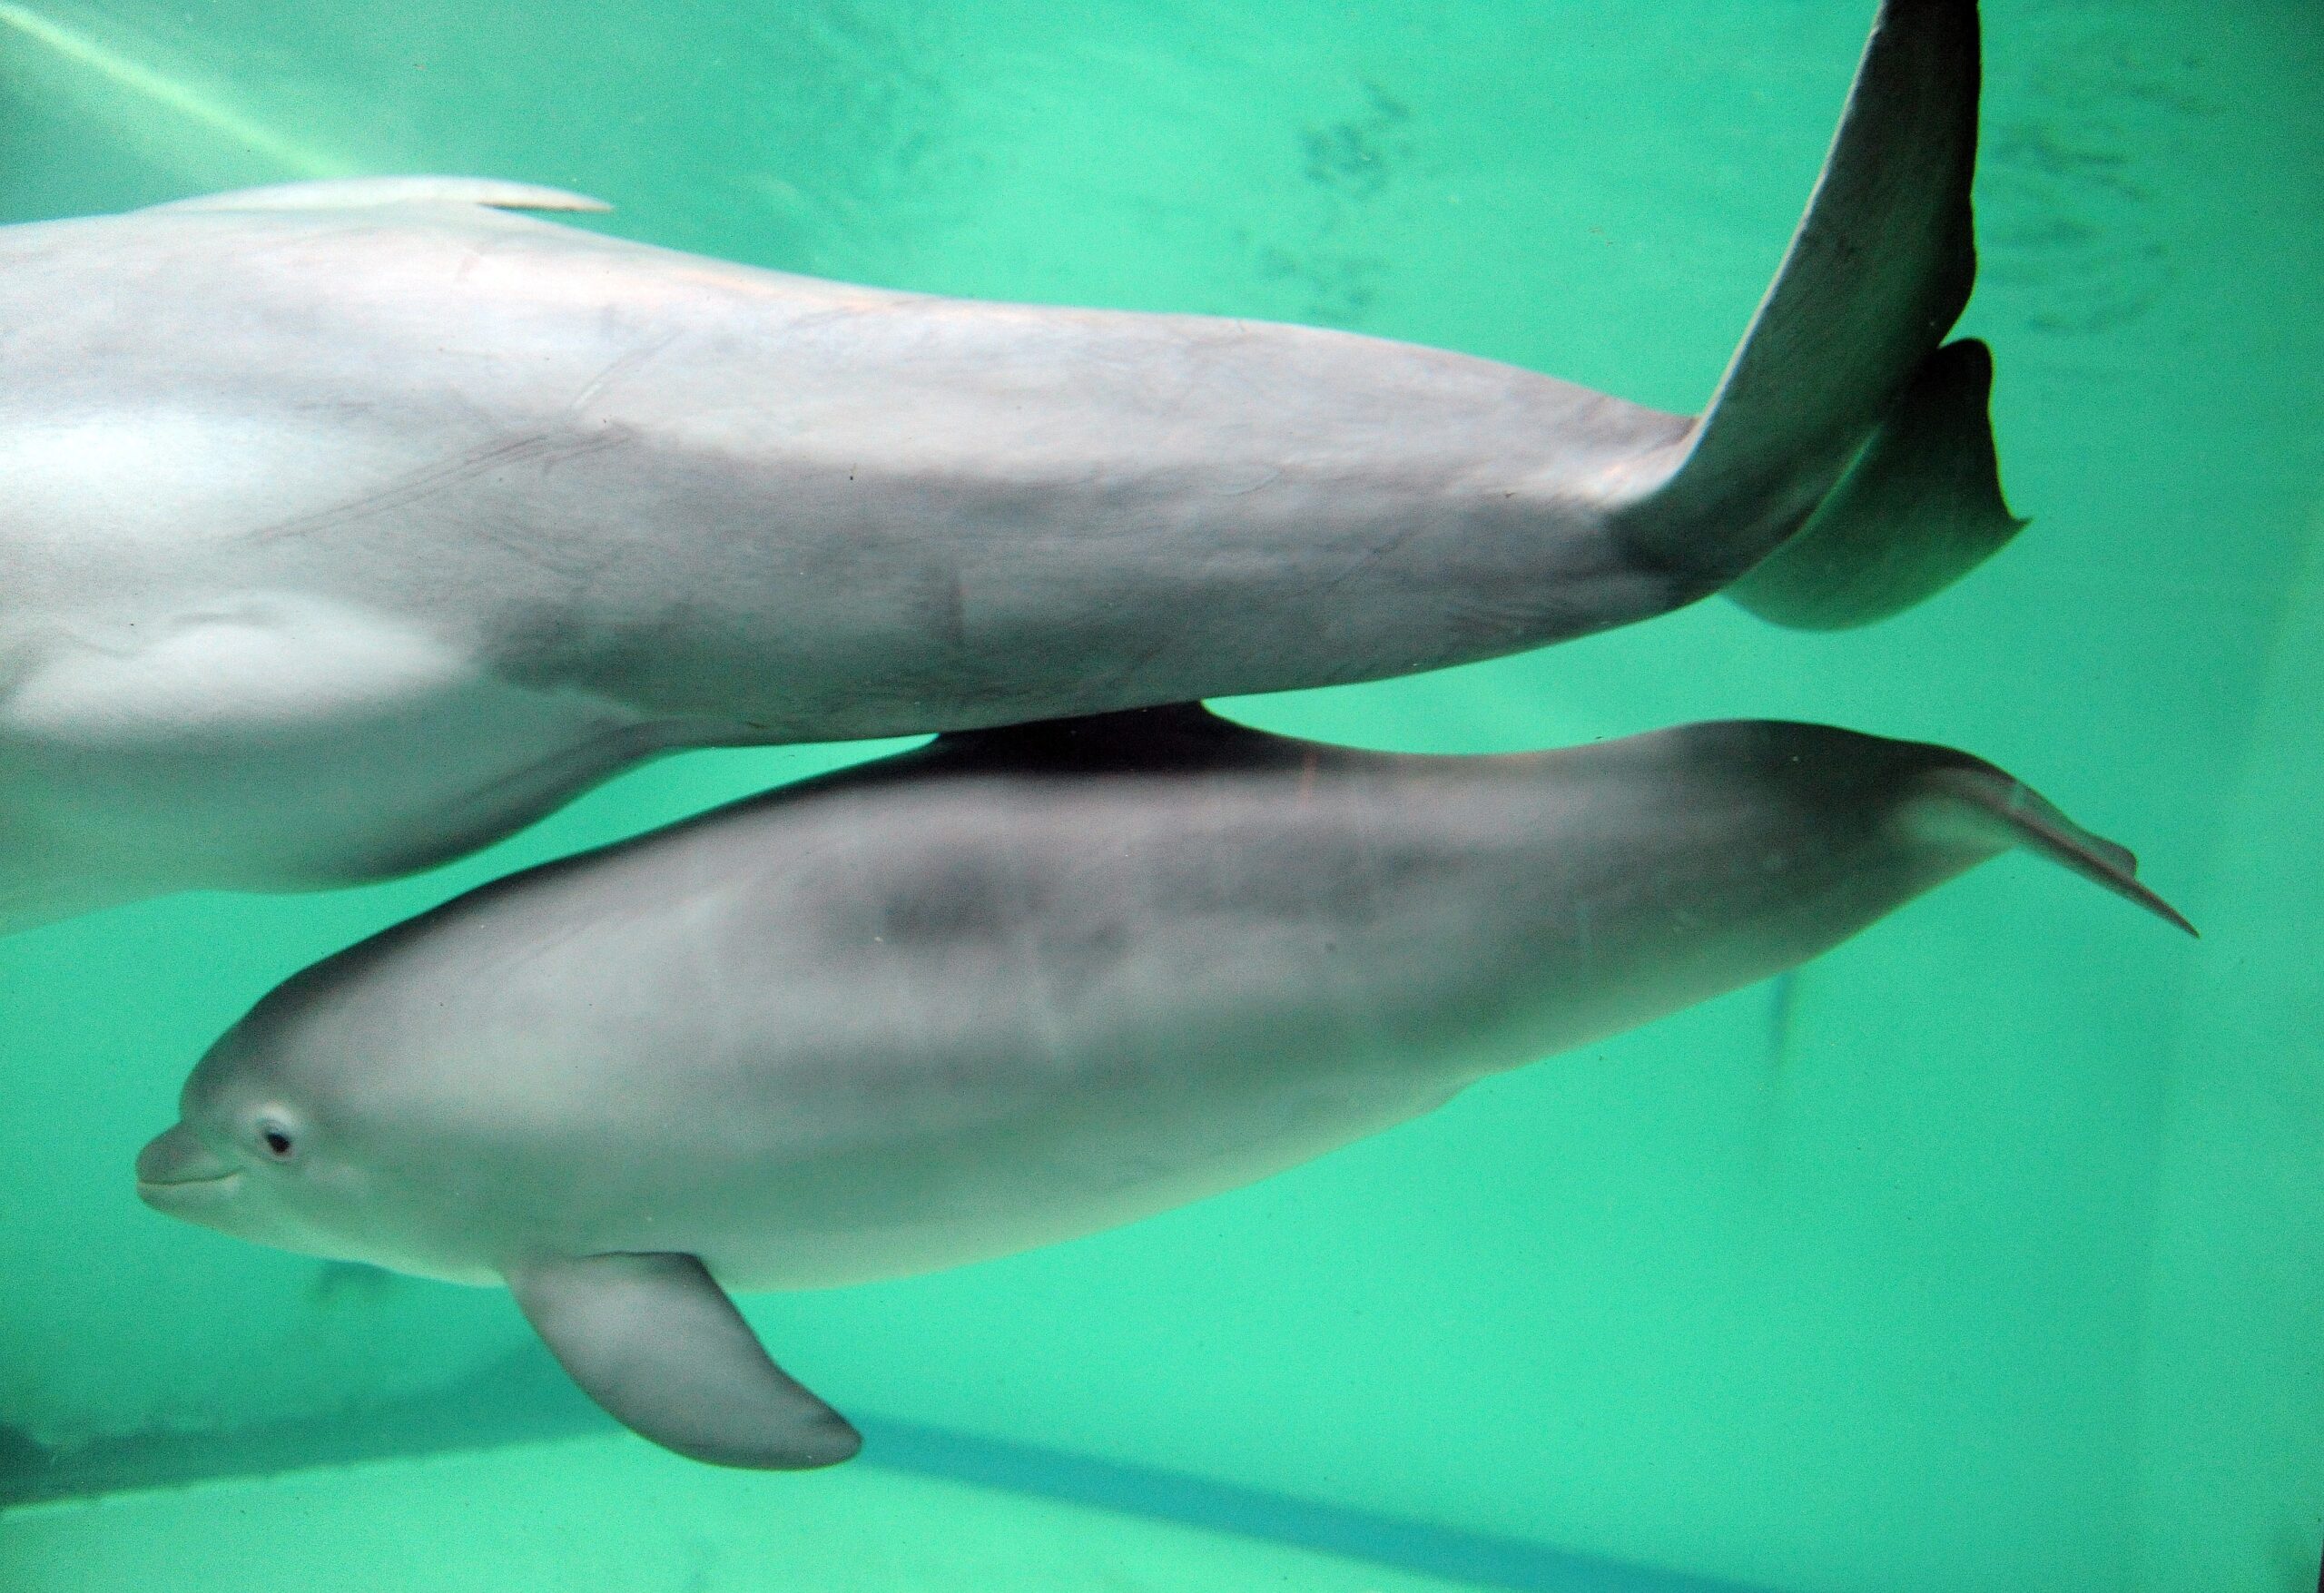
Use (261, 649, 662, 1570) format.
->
(0, 0, 2324, 1593)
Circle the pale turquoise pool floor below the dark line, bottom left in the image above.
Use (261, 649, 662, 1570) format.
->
(0, 1435, 1476, 1593)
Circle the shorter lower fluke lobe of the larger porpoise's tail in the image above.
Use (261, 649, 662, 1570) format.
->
(1725, 337, 2026, 632)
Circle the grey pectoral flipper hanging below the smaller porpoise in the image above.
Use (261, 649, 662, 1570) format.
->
(509, 1254, 862, 1472)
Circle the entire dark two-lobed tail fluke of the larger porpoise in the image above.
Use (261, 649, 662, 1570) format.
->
(1620, 0, 2017, 627)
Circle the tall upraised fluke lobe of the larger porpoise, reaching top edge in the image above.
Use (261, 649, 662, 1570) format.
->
(1620, 0, 1992, 602)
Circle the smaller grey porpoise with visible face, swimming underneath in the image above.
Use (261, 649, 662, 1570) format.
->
(137, 708, 2184, 1468)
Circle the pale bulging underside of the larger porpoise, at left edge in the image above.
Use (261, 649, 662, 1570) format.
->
(0, 592, 669, 910)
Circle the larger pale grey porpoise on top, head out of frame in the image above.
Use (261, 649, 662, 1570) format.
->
(0, 0, 2020, 929)
